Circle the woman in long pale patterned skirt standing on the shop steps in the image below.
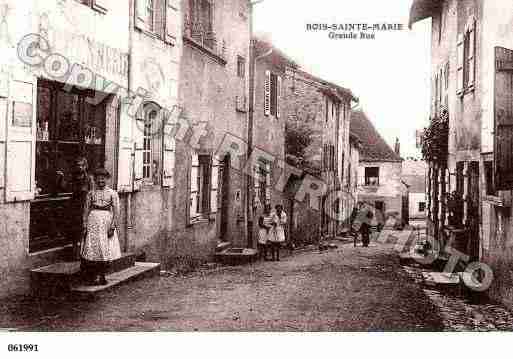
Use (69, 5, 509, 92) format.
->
(81, 168, 121, 285)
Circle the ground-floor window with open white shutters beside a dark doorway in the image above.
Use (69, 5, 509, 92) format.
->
(189, 153, 219, 223)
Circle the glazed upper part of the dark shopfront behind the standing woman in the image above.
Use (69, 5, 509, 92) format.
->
(36, 81, 105, 197)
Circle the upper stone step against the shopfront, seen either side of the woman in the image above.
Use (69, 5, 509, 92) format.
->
(30, 253, 135, 295)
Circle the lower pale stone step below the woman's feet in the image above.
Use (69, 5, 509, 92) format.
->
(70, 262, 160, 297)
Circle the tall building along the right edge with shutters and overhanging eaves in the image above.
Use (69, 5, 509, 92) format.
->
(410, 0, 513, 305)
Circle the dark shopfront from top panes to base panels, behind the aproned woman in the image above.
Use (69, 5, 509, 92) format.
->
(29, 80, 106, 253)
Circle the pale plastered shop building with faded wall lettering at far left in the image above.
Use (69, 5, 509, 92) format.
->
(0, 0, 182, 296)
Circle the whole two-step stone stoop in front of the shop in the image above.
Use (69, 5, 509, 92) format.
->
(30, 253, 160, 297)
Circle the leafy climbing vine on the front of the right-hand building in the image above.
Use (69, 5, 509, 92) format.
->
(422, 109, 449, 164)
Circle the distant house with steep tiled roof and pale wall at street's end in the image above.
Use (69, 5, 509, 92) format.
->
(351, 110, 408, 226)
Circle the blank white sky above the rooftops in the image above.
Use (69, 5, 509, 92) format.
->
(254, 0, 431, 157)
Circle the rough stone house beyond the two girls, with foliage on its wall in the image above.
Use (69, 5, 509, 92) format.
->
(283, 69, 357, 240)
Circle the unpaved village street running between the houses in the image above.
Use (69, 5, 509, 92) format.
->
(0, 236, 443, 331)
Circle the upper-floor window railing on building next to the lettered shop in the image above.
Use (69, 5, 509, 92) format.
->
(183, 15, 226, 66)
